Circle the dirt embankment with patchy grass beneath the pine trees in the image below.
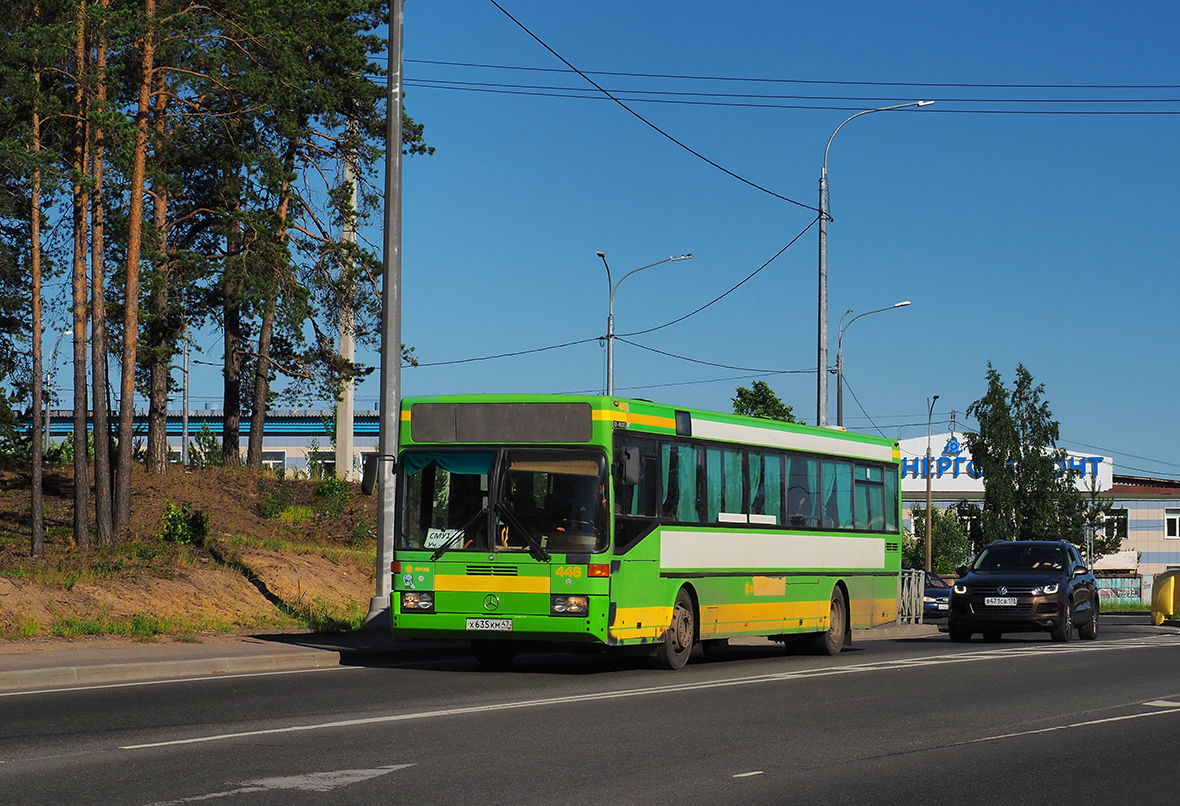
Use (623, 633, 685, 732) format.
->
(0, 467, 376, 640)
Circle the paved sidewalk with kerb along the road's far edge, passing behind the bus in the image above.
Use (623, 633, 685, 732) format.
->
(0, 624, 938, 695)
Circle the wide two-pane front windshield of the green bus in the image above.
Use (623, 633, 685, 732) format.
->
(398, 448, 610, 552)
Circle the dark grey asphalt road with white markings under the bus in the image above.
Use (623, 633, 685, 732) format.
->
(0, 617, 1180, 806)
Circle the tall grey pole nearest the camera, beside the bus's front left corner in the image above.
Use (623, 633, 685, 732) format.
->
(365, 0, 406, 630)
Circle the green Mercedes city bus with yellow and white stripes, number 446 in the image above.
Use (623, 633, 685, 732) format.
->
(389, 394, 902, 669)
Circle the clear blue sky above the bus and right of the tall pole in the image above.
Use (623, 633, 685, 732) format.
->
(94, 0, 1180, 477)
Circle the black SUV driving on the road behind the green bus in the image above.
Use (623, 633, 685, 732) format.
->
(946, 540, 1099, 641)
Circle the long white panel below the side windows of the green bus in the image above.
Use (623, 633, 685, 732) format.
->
(660, 530, 885, 571)
